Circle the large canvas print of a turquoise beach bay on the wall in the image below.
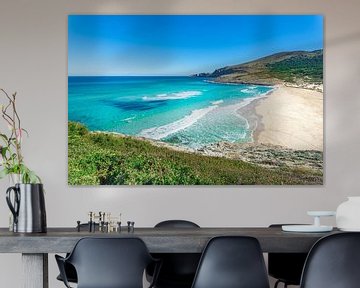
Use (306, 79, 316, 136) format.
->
(68, 15, 323, 185)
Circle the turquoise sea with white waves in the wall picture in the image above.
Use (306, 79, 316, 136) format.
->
(68, 76, 272, 149)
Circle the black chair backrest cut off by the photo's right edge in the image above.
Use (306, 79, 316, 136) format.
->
(300, 232, 360, 288)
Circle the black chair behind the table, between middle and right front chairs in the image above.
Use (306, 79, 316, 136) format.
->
(268, 224, 307, 288)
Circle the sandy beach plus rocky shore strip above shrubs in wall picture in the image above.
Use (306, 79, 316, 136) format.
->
(81, 81, 323, 170)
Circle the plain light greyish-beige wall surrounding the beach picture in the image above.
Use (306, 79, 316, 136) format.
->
(0, 0, 360, 287)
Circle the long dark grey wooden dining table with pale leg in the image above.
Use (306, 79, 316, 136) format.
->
(0, 227, 338, 288)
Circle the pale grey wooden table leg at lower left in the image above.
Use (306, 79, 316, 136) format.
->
(22, 253, 49, 288)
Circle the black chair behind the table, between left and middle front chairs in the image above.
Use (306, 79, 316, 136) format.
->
(146, 220, 201, 288)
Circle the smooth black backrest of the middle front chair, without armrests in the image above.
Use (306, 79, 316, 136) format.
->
(192, 236, 269, 288)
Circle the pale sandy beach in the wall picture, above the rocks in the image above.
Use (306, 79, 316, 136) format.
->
(254, 86, 323, 151)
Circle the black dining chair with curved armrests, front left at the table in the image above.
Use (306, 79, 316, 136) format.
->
(55, 237, 160, 288)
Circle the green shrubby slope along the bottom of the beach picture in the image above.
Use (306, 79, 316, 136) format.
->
(68, 122, 322, 185)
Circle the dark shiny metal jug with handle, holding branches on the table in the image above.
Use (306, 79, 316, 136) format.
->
(6, 184, 47, 233)
